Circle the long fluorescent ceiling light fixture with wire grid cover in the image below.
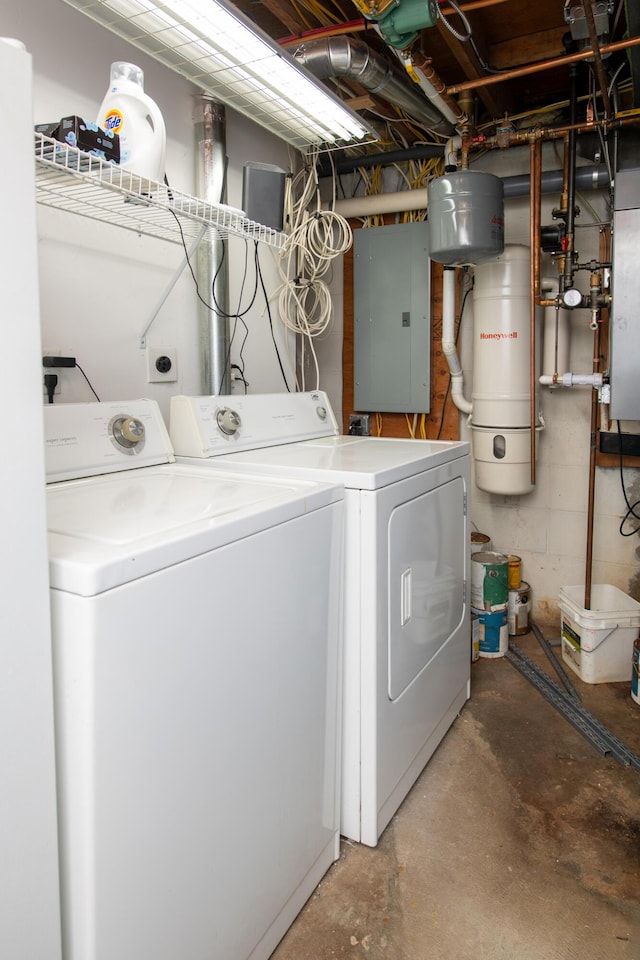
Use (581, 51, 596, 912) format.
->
(58, 0, 376, 152)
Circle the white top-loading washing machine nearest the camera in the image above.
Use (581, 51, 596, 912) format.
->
(45, 400, 343, 960)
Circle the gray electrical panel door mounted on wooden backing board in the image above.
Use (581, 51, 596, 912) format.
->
(353, 221, 431, 413)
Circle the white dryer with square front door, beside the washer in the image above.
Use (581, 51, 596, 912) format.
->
(170, 392, 471, 846)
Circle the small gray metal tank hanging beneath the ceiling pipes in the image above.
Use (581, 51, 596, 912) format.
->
(427, 170, 504, 266)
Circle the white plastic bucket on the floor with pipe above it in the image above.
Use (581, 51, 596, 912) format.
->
(559, 583, 640, 683)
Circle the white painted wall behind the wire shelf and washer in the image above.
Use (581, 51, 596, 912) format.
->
(0, 0, 296, 424)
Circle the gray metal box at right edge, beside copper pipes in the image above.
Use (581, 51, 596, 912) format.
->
(609, 170, 640, 420)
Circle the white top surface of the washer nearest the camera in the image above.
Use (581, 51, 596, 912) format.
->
(47, 464, 343, 597)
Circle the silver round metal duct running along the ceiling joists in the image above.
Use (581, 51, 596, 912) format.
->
(293, 37, 454, 137)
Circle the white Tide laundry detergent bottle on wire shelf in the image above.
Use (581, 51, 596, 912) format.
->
(96, 60, 167, 182)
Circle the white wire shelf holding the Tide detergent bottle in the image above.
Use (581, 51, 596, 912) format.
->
(34, 133, 287, 249)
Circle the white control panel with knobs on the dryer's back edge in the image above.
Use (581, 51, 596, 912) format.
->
(169, 390, 339, 458)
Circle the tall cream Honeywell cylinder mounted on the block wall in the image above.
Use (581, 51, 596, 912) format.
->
(471, 244, 540, 495)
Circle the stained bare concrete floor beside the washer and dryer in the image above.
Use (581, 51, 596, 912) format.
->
(272, 631, 640, 960)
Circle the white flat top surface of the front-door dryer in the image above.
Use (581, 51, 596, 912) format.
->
(200, 436, 469, 490)
